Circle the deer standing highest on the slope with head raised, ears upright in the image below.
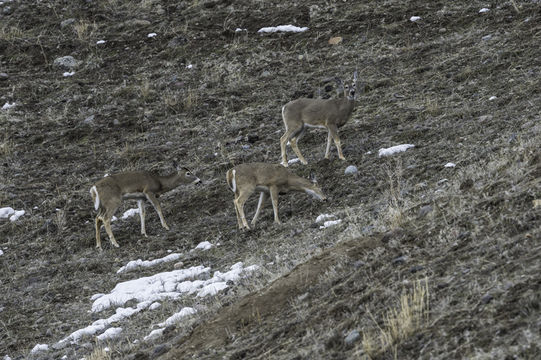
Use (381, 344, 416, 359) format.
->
(280, 71, 357, 167)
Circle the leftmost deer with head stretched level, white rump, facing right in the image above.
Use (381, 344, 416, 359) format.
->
(90, 169, 200, 249)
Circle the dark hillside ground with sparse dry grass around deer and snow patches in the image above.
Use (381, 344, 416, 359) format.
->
(0, 0, 541, 359)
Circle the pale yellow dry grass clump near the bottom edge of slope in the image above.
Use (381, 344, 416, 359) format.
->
(362, 279, 429, 359)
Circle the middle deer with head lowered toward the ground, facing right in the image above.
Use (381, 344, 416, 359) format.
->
(226, 163, 326, 229)
